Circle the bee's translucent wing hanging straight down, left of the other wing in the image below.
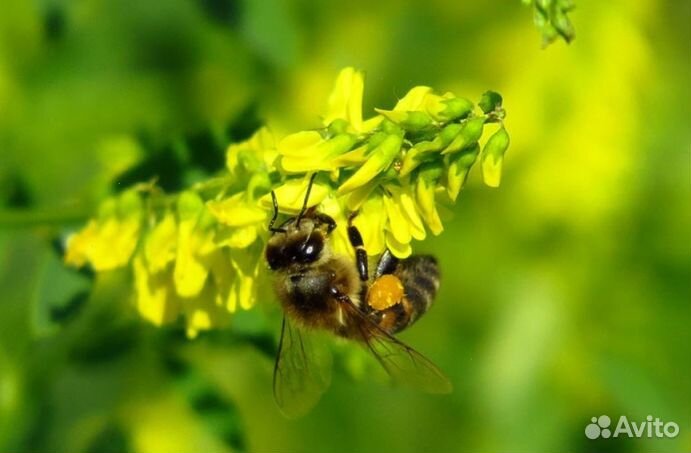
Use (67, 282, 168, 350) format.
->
(273, 316, 331, 418)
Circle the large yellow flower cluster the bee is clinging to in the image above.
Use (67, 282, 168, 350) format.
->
(65, 68, 509, 336)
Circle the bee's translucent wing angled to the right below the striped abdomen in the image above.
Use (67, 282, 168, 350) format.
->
(344, 304, 453, 393)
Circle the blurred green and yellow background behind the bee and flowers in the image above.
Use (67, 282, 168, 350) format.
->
(0, 0, 691, 453)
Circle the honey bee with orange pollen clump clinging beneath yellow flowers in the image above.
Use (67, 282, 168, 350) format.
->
(265, 173, 451, 417)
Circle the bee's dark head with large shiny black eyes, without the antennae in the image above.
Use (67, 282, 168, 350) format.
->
(266, 217, 328, 270)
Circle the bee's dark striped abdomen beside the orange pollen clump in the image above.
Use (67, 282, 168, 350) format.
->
(375, 255, 439, 333)
